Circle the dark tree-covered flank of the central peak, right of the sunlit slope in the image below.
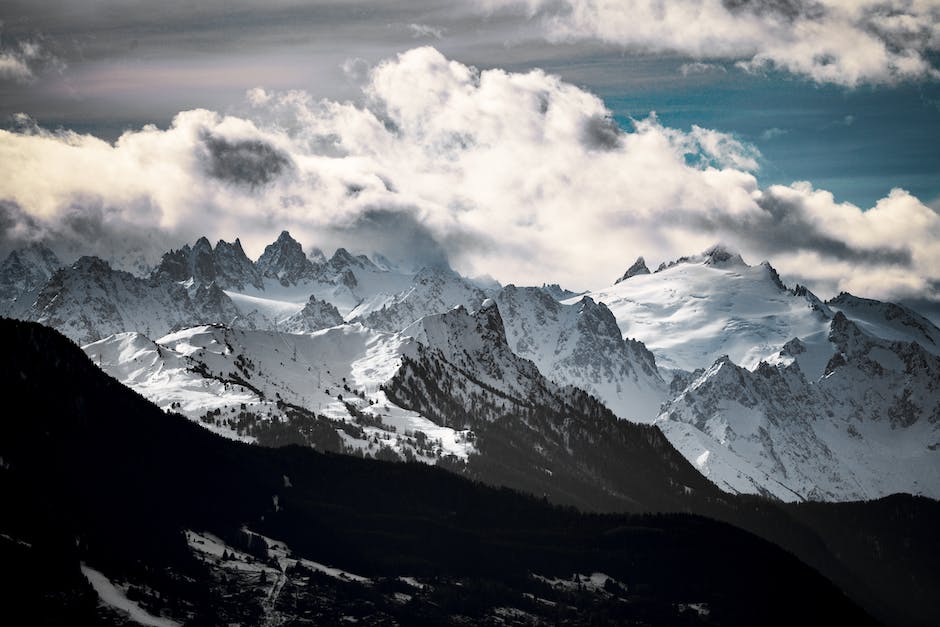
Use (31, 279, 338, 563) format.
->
(384, 299, 713, 509)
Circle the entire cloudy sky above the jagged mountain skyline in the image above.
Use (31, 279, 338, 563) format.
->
(0, 0, 940, 318)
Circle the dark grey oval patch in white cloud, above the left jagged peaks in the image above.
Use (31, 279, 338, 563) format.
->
(203, 134, 292, 187)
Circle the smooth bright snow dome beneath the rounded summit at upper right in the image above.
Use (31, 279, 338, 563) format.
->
(565, 247, 829, 371)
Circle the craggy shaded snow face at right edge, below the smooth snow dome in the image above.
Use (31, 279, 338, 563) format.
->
(656, 312, 940, 500)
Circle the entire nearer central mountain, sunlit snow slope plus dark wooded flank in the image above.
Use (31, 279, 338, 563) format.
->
(85, 301, 714, 509)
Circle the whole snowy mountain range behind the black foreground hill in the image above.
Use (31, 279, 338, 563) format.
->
(0, 231, 940, 623)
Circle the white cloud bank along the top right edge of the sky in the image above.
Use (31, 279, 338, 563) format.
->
(480, 0, 940, 86)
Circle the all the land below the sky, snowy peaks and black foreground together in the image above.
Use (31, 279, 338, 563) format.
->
(0, 231, 940, 625)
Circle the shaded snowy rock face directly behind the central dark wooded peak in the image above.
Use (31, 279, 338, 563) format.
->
(496, 285, 668, 423)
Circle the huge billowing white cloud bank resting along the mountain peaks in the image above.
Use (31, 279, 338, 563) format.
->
(0, 48, 940, 306)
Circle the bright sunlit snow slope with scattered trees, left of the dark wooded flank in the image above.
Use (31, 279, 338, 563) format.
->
(84, 324, 473, 463)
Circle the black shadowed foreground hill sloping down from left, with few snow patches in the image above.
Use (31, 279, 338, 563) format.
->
(0, 320, 871, 625)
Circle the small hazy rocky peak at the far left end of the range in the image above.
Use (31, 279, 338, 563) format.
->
(0, 243, 62, 317)
